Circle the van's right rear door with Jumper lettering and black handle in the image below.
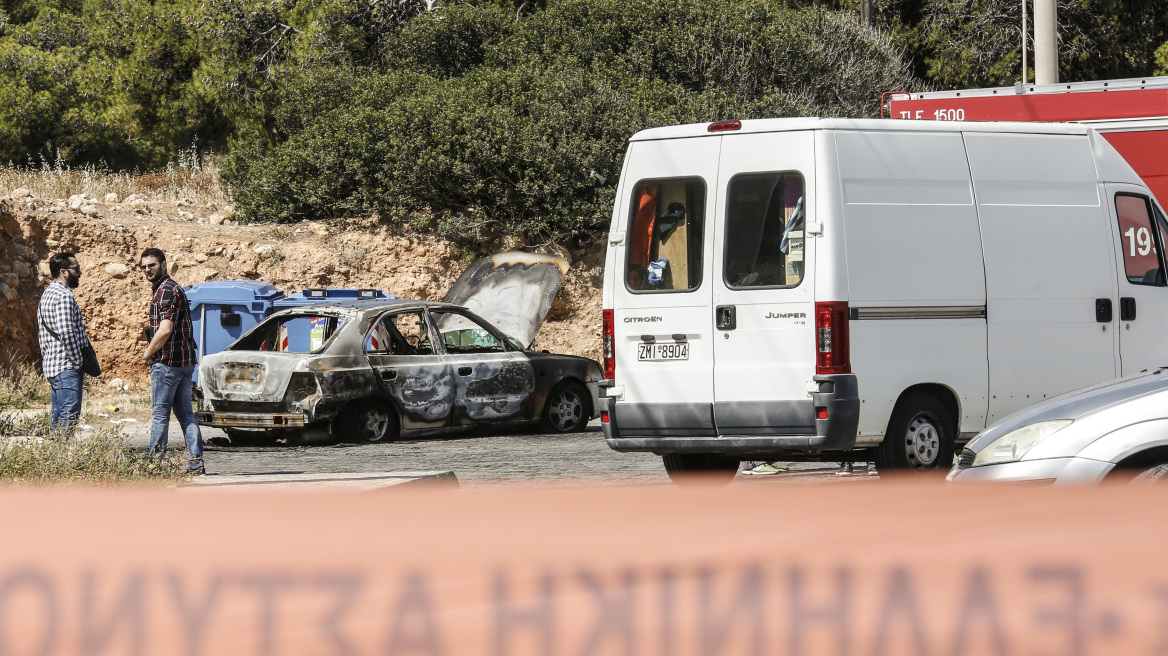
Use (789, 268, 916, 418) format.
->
(710, 131, 815, 435)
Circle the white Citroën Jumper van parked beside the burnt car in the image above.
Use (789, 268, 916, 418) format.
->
(602, 118, 1168, 475)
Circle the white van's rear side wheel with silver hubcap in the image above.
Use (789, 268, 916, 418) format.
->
(876, 392, 957, 472)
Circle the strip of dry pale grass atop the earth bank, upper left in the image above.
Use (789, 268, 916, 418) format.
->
(0, 152, 231, 207)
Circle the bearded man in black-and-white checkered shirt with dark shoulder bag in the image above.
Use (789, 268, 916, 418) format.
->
(36, 253, 89, 439)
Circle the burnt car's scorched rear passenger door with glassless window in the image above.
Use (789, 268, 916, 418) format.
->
(364, 309, 454, 431)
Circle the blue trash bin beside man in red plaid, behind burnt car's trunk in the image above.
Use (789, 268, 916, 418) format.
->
(182, 280, 284, 385)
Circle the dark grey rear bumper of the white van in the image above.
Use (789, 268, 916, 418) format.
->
(600, 374, 860, 459)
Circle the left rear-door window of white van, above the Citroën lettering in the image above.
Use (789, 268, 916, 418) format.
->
(625, 177, 705, 292)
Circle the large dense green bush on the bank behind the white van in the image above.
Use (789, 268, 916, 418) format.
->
(223, 0, 913, 242)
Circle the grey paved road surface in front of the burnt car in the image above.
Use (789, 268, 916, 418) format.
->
(123, 420, 874, 487)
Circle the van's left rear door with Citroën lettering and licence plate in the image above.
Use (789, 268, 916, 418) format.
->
(610, 135, 721, 437)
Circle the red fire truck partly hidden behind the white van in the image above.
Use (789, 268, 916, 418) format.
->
(881, 77, 1168, 205)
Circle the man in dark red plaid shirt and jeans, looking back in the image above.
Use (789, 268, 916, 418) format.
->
(141, 249, 204, 474)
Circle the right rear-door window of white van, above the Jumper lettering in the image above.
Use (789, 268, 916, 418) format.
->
(722, 173, 804, 288)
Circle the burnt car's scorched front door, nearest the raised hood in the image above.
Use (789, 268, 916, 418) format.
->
(430, 309, 535, 426)
